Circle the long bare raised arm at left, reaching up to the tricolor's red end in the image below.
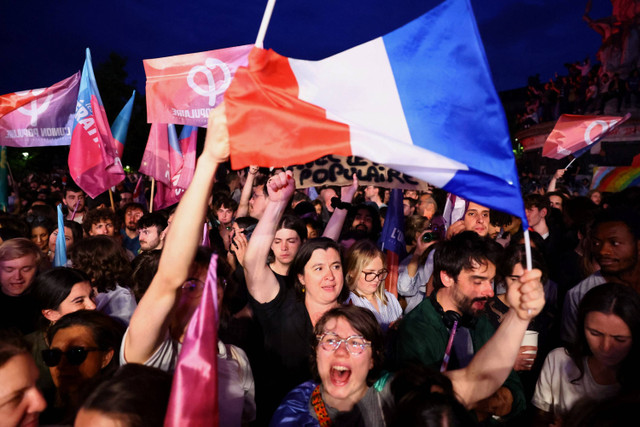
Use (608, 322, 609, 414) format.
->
(124, 109, 229, 363)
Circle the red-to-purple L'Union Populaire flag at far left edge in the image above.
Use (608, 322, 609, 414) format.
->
(0, 72, 80, 147)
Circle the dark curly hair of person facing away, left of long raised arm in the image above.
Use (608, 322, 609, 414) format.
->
(71, 236, 132, 292)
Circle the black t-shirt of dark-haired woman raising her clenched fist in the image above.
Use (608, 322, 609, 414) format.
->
(249, 275, 313, 420)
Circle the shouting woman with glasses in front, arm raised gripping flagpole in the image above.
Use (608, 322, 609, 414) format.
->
(270, 300, 544, 427)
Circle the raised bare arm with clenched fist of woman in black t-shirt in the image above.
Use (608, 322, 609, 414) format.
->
(244, 171, 296, 303)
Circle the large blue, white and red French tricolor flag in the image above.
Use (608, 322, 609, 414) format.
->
(224, 0, 525, 222)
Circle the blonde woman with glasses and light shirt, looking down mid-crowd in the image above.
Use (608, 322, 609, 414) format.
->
(345, 240, 402, 331)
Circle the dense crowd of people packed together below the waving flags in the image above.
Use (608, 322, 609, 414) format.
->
(0, 114, 640, 426)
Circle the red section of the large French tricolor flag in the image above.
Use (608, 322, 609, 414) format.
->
(224, 48, 351, 169)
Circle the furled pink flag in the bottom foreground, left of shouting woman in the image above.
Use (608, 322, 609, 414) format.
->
(164, 255, 219, 427)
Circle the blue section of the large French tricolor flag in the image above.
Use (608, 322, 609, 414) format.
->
(382, 0, 526, 226)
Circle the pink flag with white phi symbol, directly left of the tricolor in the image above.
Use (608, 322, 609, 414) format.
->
(142, 45, 252, 127)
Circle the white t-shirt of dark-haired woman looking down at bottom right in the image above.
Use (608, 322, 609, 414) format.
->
(531, 347, 620, 417)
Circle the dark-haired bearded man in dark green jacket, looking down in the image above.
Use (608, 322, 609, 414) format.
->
(397, 231, 526, 421)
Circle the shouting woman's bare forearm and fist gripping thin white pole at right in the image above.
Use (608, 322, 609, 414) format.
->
(445, 269, 544, 408)
